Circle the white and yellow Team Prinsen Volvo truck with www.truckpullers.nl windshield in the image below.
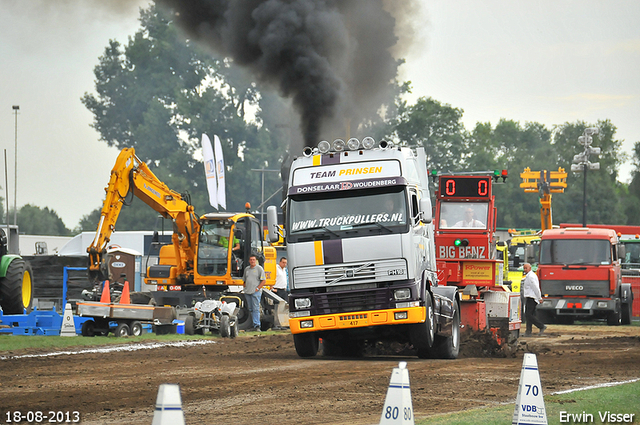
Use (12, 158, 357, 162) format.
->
(267, 137, 460, 358)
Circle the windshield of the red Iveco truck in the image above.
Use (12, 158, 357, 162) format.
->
(540, 239, 611, 265)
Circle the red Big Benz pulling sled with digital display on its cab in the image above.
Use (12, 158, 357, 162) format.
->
(432, 170, 521, 346)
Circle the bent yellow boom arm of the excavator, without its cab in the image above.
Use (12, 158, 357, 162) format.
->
(87, 148, 200, 280)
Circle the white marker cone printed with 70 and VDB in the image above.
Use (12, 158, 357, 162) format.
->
(512, 353, 547, 425)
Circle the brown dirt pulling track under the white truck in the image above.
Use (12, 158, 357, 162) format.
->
(0, 325, 640, 425)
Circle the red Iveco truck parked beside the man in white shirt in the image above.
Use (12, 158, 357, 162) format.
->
(537, 227, 633, 326)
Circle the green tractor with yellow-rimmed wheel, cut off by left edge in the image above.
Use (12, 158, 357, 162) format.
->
(0, 228, 33, 314)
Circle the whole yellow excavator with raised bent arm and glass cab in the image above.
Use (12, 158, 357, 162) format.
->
(87, 148, 276, 329)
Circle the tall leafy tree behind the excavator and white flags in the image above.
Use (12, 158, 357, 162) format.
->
(80, 6, 286, 230)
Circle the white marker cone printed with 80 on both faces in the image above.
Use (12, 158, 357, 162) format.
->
(380, 362, 414, 425)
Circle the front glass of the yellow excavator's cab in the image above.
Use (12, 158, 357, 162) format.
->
(197, 221, 235, 276)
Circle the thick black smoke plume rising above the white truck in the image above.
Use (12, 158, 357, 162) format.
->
(156, 0, 410, 146)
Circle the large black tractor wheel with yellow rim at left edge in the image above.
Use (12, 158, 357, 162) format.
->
(0, 258, 33, 314)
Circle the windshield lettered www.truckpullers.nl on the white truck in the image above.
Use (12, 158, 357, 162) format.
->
(289, 187, 407, 236)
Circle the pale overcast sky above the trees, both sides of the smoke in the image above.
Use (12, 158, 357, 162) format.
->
(0, 0, 640, 228)
